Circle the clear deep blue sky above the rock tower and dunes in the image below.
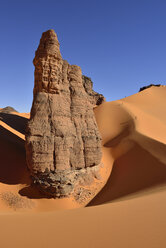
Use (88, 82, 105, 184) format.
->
(0, 0, 166, 112)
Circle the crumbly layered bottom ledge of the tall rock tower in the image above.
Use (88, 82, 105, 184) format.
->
(32, 165, 101, 198)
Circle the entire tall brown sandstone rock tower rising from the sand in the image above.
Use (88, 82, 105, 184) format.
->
(26, 30, 104, 197)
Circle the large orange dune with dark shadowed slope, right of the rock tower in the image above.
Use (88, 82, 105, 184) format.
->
(89, 87, 166, 206)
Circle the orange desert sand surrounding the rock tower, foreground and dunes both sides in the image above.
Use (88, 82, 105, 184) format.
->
(0, 87, 166, 248)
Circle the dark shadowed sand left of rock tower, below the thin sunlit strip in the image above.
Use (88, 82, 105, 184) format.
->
(0, 126, 29, 184)
